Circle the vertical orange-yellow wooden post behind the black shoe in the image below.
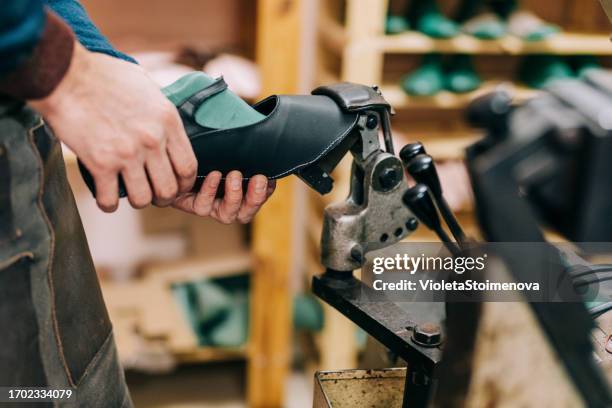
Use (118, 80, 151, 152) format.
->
(247, 0, 301, 407)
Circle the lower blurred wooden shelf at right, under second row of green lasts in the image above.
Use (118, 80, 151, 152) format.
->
(380, 81, 536, 109)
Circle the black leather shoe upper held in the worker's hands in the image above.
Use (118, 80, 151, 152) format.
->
(178, 78, 358, 183)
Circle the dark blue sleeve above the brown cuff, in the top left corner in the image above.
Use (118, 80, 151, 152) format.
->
(0, 0, 45, 74)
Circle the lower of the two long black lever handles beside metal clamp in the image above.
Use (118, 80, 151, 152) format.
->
(402, 184, 460, 255)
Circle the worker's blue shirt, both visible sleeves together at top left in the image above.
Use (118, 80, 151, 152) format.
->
(0, 0, 136, 74)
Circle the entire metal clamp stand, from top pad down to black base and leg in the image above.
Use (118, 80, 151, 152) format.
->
(308, 84, 444, 406)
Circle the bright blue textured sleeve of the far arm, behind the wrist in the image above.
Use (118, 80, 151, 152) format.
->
(45, 0, 136, 63)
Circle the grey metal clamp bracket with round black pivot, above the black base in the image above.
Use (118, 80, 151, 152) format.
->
(314, 88, 418, 274)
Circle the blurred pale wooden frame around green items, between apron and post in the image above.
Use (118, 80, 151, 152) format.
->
(102, 253, 252, 364)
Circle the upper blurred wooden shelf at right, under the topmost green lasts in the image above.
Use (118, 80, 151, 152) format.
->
(349, 31, 612, 55)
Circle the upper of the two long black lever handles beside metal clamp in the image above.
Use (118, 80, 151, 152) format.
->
(406, 154, 467, 245)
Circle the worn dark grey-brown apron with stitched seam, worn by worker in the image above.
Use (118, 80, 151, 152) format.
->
(0, 102, 131, 407)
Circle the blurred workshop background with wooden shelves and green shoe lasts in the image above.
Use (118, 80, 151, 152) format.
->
(61, 0, 612, 407)
